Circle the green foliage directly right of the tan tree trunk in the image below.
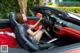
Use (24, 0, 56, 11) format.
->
(27, 0, 44, 15)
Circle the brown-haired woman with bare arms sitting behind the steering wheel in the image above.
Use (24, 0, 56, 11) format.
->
(17, 14, 43, 42)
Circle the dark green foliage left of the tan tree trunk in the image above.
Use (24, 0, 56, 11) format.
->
(0, 0, 19, 18)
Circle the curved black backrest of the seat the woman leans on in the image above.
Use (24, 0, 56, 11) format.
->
(9, 12, 39, 50)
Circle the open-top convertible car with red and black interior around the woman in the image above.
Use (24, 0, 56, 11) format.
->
(0, 7, 80, 53)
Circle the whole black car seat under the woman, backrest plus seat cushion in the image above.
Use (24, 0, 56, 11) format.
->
(9, 12, 53, 51)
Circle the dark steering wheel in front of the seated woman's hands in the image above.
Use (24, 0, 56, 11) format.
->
(41, 15, 54, 33)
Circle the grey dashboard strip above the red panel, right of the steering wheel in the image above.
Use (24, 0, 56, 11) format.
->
(51, 14, 80, 31)
